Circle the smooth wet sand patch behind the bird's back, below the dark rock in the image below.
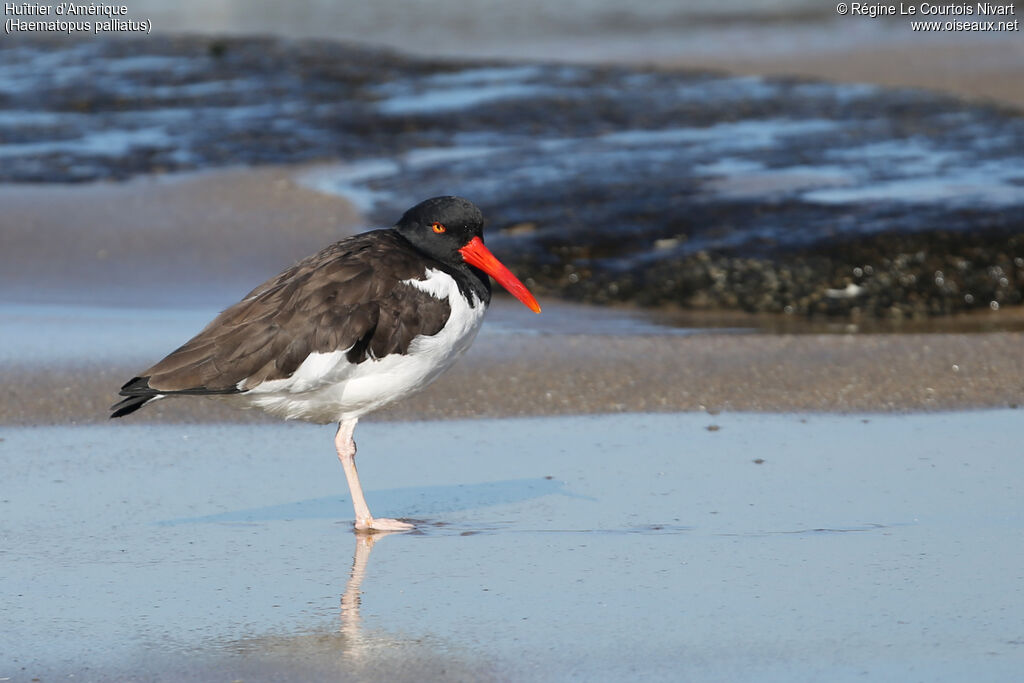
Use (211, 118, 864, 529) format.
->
(0, 167, 359, 306)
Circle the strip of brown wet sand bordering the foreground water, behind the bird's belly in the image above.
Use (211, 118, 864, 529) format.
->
(6, 321, 1024, 425)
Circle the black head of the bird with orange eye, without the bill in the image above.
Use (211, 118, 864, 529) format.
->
(394, 197, 483, 265)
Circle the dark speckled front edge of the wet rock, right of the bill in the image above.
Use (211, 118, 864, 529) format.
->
(514, 230, 1024, 318)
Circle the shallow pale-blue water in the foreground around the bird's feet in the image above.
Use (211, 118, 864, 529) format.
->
(0, 411, 1024, 681)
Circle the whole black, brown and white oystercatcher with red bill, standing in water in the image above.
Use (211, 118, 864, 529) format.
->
(111, 197, 541, 531)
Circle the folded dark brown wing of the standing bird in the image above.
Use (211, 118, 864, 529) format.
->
(121, 230, 451, 396)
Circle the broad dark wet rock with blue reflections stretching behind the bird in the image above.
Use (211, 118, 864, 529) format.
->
(6, 38, 1024, 317)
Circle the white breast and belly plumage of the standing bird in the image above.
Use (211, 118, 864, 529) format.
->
(231, 268, 485, 423)
